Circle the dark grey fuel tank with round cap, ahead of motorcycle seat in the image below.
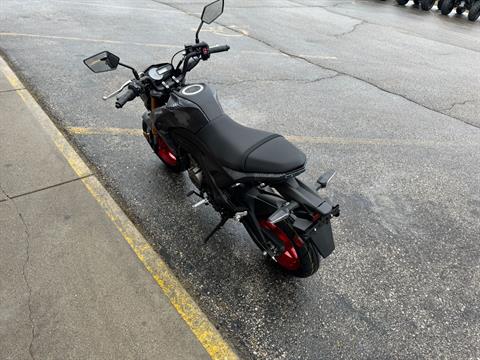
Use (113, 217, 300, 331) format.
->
(153, 83, 224, 134)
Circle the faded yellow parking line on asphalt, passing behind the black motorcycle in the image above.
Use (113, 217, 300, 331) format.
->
(66, 127, 480, 147)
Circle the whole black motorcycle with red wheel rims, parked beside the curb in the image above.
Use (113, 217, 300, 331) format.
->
(84, 0, 339, 277)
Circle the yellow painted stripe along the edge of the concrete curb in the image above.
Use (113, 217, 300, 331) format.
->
(0, 58, 238, 360)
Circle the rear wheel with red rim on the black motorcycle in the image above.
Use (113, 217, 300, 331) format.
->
(260, 220, 320, 277)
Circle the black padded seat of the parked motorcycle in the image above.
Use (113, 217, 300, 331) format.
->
(198, 113, 306, 174)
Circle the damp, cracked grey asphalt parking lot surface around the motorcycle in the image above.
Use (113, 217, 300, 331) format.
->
(0, 0, 480, 359)
